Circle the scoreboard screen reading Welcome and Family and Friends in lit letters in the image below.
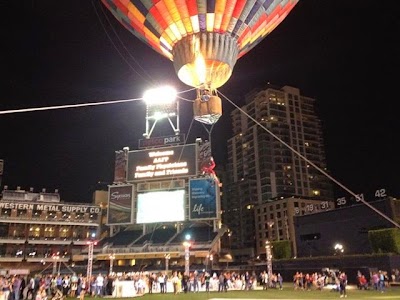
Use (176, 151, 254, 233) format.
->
(128, 144, 197, 181)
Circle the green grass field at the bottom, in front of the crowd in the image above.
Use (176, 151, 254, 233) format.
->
(85, 284, 400, 300)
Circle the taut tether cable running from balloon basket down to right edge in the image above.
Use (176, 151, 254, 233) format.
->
(219, 92, 400, 228)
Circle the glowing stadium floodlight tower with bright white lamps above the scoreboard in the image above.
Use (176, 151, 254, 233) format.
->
(143, 86, 180, 139)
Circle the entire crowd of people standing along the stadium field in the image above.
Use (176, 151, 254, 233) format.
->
(0, 270, 400, 300)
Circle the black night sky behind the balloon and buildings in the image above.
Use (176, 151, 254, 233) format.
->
(0, 0, 400, 202)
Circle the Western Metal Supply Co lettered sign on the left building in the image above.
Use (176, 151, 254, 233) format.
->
(0, 201, 101, 213)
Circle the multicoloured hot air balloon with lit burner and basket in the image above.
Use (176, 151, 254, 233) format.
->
(102, 0, 299, 124)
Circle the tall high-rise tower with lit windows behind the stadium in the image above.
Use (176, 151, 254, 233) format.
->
(222, 85, 333, 259)
